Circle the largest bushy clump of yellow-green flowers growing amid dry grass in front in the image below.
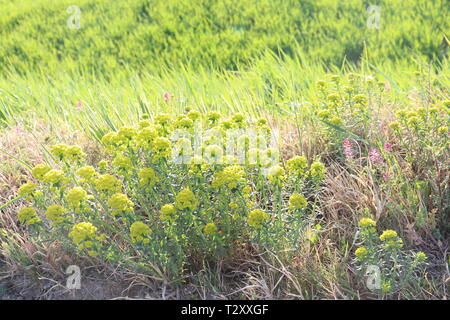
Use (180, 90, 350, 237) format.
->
(12, 111, 326, 278)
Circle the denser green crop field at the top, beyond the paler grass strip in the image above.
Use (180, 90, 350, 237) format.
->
(0, 0, 450, 74)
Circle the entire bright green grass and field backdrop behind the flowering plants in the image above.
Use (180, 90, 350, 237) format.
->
(0, 0, 450, 131)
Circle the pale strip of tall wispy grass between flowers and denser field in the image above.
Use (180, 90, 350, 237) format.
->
(0, 54, 450, 132)
